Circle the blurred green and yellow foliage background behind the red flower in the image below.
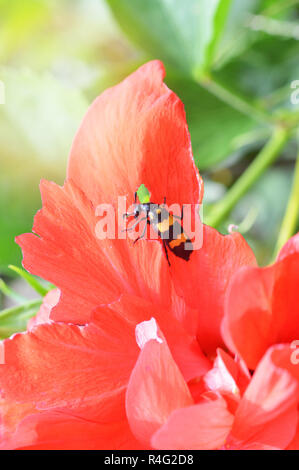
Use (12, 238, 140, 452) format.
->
(0, 0, 299, 314)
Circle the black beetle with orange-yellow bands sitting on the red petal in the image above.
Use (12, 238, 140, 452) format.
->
(124, 185, 192, 265)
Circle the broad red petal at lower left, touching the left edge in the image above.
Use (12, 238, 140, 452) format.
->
(0, 320, 134, 411)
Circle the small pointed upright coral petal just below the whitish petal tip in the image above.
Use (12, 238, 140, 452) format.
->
(126, 324, 193, 445)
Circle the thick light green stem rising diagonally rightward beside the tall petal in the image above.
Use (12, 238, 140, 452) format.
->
(205, 127, 290, 227)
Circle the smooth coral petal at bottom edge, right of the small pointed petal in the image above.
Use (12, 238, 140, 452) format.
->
(152, 397, 234, 450)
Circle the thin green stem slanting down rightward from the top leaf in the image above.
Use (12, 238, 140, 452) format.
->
(197, 76, 273, 125)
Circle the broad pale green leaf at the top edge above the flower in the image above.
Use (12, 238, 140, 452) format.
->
(107, 0, 231, 75)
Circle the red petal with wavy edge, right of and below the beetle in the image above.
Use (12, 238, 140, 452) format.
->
(171, 225, 256, 353)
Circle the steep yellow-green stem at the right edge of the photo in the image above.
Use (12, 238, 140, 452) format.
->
(275, 154, 299, 257)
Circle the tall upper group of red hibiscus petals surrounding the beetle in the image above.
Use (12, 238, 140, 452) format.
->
(17, 61, 256, 354)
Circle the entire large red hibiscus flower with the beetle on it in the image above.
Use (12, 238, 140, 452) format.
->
(0, 61, 298, 449)
